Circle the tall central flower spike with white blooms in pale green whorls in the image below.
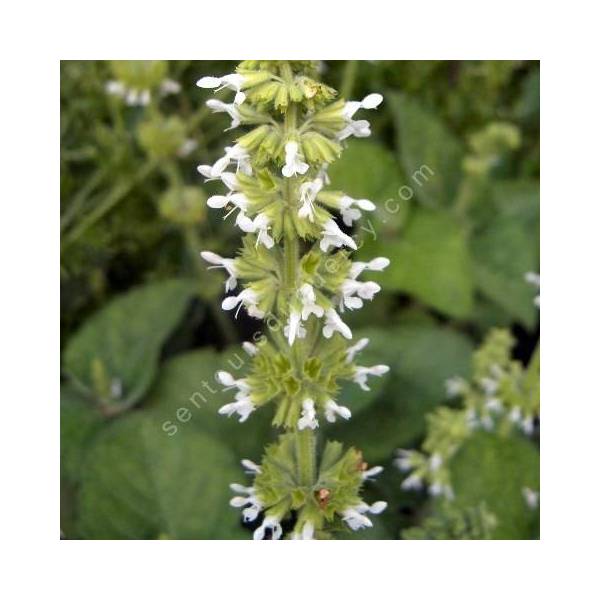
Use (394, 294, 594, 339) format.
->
(197, 61, 389, 539)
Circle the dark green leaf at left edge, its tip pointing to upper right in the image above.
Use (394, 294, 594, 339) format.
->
(64, 280, 195, 412)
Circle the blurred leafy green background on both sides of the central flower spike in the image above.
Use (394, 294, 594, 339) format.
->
(61, 61, 540, 539)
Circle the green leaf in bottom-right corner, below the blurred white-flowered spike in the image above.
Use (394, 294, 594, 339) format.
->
(449, 432, 540, 539)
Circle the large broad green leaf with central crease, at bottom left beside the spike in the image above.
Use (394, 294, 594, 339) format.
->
(79, 412, 247, 539)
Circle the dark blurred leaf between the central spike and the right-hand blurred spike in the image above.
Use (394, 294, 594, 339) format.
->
(328, 325, 473, 464)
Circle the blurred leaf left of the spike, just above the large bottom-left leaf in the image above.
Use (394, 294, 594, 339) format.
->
(145, 348, 273, 462)
